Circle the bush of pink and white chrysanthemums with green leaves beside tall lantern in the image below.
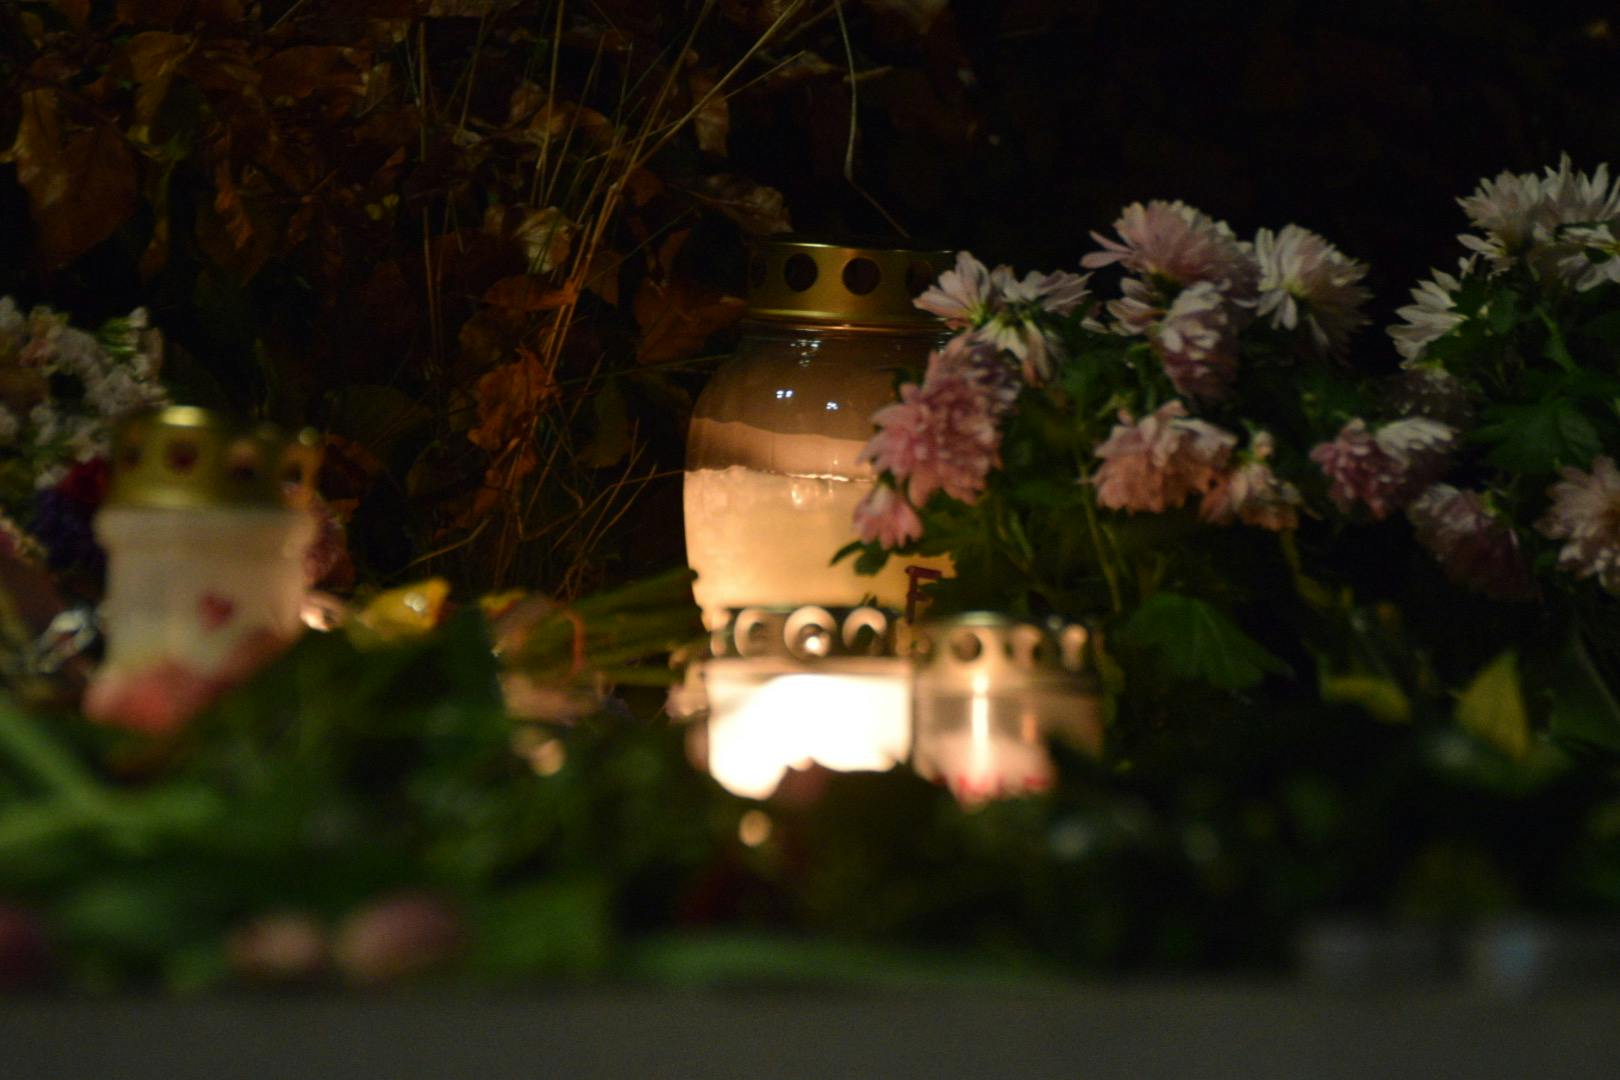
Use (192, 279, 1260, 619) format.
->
(841, 160, 1620, 755)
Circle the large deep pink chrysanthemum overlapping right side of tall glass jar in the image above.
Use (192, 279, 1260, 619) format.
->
(860, 335, 1011, 507)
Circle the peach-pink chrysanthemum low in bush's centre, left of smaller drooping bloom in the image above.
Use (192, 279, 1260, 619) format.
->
(1092, 402, 1238, 513)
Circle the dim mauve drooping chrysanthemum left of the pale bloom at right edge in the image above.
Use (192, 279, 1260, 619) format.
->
(1406, 484, 1536, 601)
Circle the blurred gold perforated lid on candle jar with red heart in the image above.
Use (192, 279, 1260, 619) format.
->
(107, 405, 321, 508)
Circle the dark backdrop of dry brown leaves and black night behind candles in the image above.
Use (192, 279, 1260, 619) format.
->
(0, 0, 1620, 589)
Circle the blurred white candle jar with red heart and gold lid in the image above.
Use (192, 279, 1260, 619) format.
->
(86, 406, 318, 714)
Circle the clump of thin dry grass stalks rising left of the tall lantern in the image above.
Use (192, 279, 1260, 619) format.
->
(416, 0, 808, 597)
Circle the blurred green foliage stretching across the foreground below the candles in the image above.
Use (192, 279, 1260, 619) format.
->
(0, 592, 1620, 991)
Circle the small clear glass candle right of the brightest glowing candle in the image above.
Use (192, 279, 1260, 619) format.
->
(912, 612, 1102, 803)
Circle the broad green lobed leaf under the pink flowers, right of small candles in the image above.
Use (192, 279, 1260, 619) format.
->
(1119, 593, 1290, 690)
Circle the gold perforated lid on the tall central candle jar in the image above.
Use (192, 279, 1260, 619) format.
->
(748, 240, 953, 329)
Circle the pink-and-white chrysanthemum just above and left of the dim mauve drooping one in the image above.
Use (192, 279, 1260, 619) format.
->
(1311, 416, 1456, 520)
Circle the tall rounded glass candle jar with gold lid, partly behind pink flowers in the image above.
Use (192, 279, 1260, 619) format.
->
(685, 241, 949, 628)
